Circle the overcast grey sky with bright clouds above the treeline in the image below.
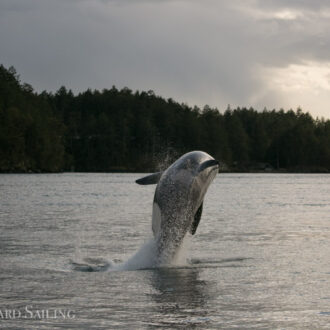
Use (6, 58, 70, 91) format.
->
(0, 0, 330, 118)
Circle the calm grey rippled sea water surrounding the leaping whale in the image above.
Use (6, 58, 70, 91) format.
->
(0, 173, 330, 329)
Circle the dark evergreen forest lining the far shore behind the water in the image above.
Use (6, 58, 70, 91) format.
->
(0, 65, 330, 172)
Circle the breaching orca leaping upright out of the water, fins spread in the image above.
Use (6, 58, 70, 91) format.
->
(136, 151, 219, 264)
